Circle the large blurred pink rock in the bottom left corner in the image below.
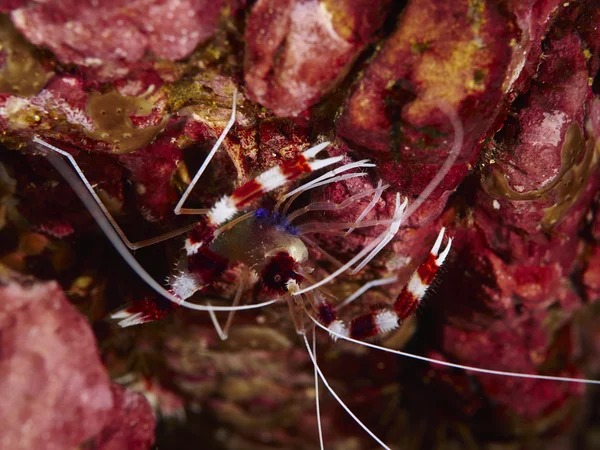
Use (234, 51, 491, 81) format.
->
(0, 282, 113, 450)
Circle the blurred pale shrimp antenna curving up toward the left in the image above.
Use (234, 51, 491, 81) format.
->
(33, 136, 278, 312)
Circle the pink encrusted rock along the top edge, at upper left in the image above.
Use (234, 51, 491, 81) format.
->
(11, 0, 235, 69)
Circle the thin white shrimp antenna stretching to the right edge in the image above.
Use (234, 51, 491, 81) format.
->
(308, 314, 600, 384)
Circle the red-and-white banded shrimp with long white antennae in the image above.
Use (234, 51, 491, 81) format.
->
(29, 88, 600, 448)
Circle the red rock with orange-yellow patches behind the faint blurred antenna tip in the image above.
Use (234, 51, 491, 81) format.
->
(330, 1, 513, 239)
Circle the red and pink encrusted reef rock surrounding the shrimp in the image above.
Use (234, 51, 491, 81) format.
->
(0, 0, 600, 450)
